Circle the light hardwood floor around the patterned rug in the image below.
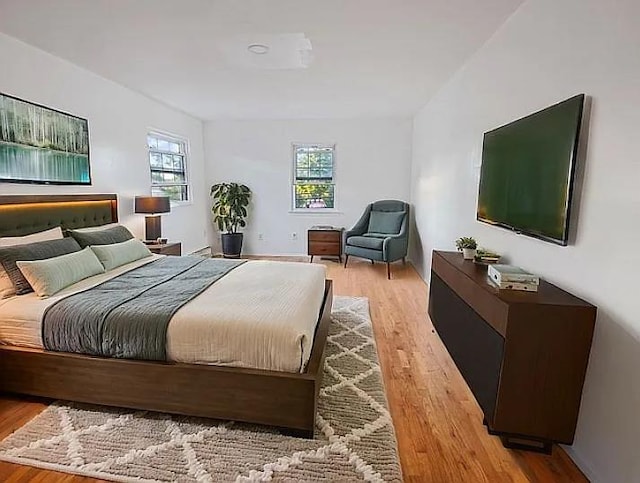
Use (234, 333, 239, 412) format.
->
(0, 259, 587, 483)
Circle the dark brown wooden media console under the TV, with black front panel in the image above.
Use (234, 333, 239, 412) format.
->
(429, 251, 596, 452)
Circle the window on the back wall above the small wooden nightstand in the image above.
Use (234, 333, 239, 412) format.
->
(293, 144, 336, 209)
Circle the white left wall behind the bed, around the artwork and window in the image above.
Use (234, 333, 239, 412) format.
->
(0, 34, 208, 252)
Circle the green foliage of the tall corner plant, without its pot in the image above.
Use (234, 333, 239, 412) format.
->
(210, 183, 251, 233)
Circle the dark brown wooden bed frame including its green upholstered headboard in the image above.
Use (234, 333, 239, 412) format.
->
(0, 195, 333, 438)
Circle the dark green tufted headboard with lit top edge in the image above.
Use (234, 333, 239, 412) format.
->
(0, 194, 118, 237)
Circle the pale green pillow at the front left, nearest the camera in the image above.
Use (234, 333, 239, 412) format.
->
(16, 247, 104, 297)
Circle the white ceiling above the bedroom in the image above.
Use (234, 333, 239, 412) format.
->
(0, 0, 522, 120)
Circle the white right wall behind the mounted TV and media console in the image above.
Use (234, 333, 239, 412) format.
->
(412, 0, 640, 483)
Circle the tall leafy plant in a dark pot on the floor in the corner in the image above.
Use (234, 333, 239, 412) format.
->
(211, 183, 251, 258)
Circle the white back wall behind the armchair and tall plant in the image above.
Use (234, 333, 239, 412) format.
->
(205, 119, 411, 255)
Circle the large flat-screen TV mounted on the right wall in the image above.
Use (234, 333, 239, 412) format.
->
(477, 94, 584, 245)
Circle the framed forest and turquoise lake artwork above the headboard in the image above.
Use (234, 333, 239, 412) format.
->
(0, 93, 91, 185)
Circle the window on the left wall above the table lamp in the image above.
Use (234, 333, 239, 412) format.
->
(147, 133, 189, 201)
